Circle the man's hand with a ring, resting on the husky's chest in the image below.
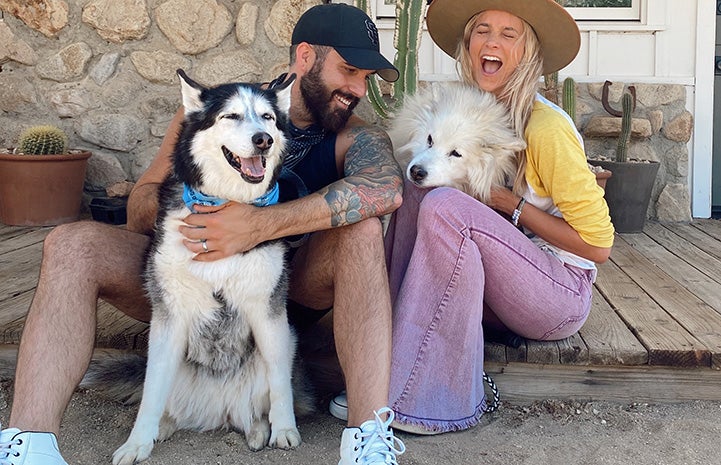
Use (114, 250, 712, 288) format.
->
(180, 202, 266, 262)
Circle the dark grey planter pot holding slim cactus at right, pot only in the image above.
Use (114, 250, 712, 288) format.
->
(589, 160, 660, 233)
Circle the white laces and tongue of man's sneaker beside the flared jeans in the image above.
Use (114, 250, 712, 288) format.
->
(355, 407, 406, 465)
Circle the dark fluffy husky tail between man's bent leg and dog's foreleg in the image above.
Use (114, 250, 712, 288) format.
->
(79, 351, 147, 404)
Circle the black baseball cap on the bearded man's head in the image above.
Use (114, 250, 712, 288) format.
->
(291, 3, 399, 82)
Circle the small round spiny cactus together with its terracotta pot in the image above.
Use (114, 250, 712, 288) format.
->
(0, 125, 91, 226)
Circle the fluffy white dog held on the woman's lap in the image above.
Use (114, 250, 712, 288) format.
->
(389, 83, 526, 203)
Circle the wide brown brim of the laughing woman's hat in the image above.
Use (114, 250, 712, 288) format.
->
(426, 0, 581, 74)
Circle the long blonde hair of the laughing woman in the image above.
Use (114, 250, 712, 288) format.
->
(456, 12, 543, 195)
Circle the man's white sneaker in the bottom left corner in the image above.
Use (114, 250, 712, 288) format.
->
(0, 428, 68, 465)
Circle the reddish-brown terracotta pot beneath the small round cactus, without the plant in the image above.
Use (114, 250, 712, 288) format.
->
(0, 151, 91, 226)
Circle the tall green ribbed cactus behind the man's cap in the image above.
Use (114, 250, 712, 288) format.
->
(356, 0, 425, 119)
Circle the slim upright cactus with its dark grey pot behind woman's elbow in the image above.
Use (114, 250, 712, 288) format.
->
(589, 88, 660, 233)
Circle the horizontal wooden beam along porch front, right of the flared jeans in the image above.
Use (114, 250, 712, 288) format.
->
(485, 363, 721, 403)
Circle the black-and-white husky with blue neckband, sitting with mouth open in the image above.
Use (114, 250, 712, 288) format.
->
(113, 70, 301, 465)
